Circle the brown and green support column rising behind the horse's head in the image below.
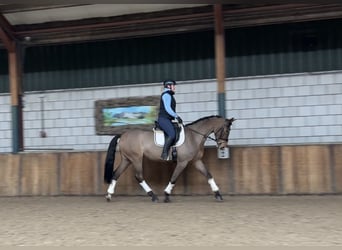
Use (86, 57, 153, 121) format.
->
(214, 4, 226, 117)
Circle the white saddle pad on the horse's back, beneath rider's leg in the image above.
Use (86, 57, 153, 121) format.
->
(153, 121, 185, 147)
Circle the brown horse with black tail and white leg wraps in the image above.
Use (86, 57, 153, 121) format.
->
(104, 115, 235, 202)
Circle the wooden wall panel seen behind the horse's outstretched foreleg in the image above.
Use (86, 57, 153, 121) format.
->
(185, 148, 230, 194)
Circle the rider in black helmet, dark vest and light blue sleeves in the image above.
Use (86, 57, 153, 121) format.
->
(158, 80, 183, 160)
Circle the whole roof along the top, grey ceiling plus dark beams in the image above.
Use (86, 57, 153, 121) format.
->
(0, 3, 342, 46)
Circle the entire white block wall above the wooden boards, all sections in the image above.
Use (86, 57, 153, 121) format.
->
(0, 71, 342, 153)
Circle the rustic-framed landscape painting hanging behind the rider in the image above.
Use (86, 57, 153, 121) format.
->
(95, 96, 160, 135)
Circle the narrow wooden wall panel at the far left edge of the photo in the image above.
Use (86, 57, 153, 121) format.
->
(0, 154, 19, 196)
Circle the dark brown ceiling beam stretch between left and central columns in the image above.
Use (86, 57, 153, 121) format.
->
(15, 6, 214, 45)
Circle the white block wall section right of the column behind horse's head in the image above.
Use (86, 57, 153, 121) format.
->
(226, 72, 342, 145)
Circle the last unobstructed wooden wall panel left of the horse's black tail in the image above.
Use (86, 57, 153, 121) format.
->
(60, 152, 99, 195)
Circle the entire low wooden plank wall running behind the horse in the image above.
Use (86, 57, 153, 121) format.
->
(0, 145, 342, 196)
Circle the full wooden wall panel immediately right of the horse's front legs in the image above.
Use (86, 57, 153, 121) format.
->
(232, 147, 279, 194)
